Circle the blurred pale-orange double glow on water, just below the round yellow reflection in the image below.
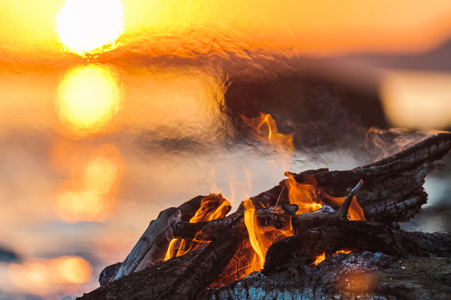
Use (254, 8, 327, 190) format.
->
(55, 144, 122, 223)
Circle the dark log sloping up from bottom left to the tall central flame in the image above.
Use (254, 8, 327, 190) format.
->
(79, 214, 247, 299)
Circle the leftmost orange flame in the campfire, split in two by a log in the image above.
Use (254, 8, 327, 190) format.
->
(164, 194, 231, 260)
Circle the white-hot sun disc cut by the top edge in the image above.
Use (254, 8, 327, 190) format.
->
(55, 0, 124, 56)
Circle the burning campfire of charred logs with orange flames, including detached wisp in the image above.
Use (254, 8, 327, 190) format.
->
(80, 114, 451, 299)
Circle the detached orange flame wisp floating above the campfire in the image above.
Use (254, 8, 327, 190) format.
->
(241, 113, 294, 169)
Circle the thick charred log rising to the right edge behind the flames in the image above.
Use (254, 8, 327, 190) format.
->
(238, 132, 451, 223)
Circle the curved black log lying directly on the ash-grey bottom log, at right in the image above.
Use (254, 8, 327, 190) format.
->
(263, 221, 451, 275)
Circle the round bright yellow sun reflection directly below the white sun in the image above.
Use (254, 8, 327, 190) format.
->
(56, 64, 121, 137)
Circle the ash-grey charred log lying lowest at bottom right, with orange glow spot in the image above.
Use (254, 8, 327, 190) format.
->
(199, 252, 451, 300)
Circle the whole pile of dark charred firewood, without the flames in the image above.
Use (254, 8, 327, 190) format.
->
(81, 133, 451, 299)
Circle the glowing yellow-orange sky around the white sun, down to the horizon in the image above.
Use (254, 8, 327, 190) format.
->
(0, 0, 451, 58)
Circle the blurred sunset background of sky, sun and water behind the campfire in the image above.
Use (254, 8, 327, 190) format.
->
(0, 0, 451, 300)
